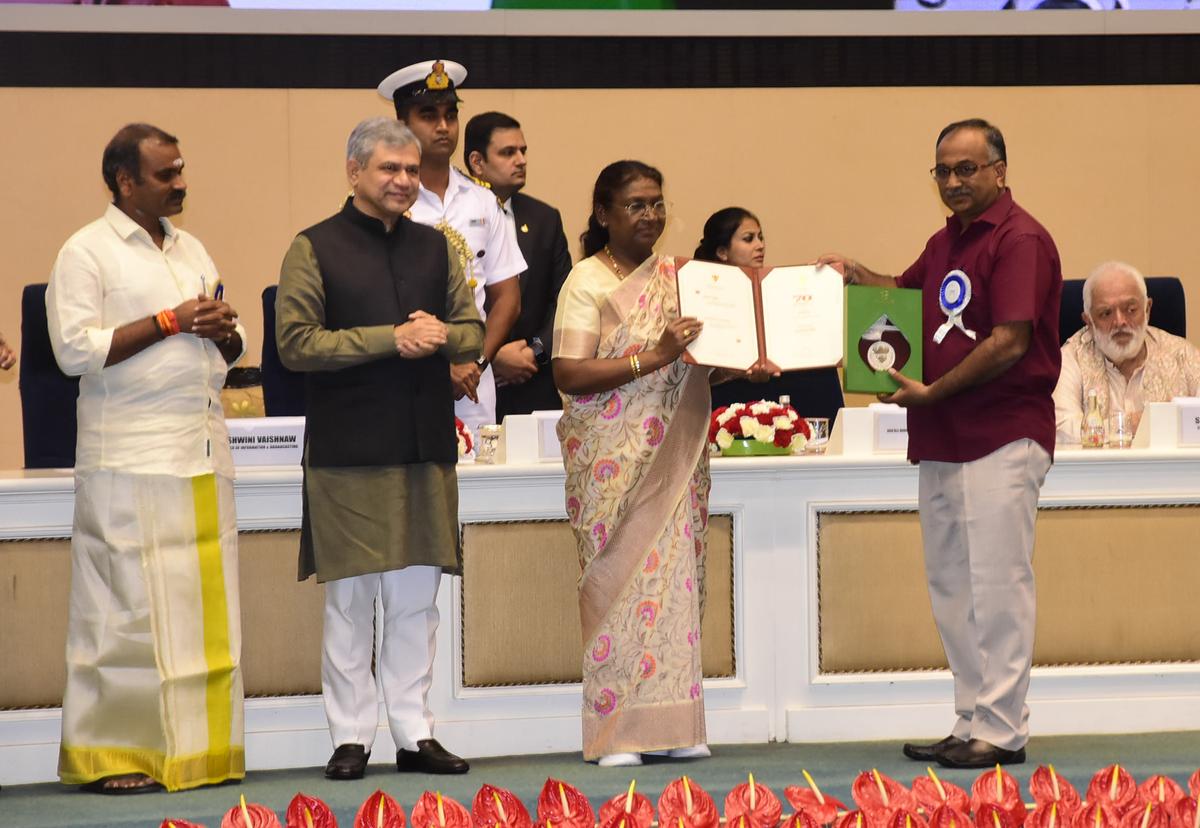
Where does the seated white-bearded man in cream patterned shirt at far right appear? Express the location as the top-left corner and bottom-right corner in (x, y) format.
(1054, 262), (1200, 445)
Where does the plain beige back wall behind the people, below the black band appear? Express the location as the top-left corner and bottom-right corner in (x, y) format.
(0, 84), (1200, 467)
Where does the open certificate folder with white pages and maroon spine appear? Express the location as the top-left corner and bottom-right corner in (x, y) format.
(676, 258), (845, 371)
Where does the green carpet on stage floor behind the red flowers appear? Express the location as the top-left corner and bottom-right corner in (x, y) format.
(0, 731), (1200, 828)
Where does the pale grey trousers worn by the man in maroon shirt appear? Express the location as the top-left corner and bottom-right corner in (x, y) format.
(919, 439), (1050, 750)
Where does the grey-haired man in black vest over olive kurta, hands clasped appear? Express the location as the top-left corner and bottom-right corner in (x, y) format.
(276, 118), (484, 779)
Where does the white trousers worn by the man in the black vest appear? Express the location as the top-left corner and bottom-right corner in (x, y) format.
(320, 566), (442, 751)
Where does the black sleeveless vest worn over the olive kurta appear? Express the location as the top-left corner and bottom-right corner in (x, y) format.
(301, 200), (458, 467)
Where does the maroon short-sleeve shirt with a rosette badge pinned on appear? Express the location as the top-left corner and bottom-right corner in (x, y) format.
(898, 190), (1062, 463)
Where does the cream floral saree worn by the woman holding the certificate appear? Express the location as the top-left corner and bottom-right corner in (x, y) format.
(558, 258), (709, 760)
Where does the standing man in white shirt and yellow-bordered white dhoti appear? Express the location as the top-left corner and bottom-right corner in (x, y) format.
(46, 124), (245, 793)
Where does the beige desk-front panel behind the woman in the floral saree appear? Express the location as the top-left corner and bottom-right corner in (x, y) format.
(462, 515), (734, 686)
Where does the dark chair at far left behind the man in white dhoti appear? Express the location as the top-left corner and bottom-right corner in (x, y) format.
(18, 282), (79, 469)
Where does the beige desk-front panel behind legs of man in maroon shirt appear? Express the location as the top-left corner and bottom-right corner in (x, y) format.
(818, 506), (1200, 672)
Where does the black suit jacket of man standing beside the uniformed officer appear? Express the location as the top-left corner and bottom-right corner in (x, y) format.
(496, 193), (571, 420)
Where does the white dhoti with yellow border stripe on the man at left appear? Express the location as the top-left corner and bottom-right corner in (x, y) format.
(59, 470), (245, 791)
